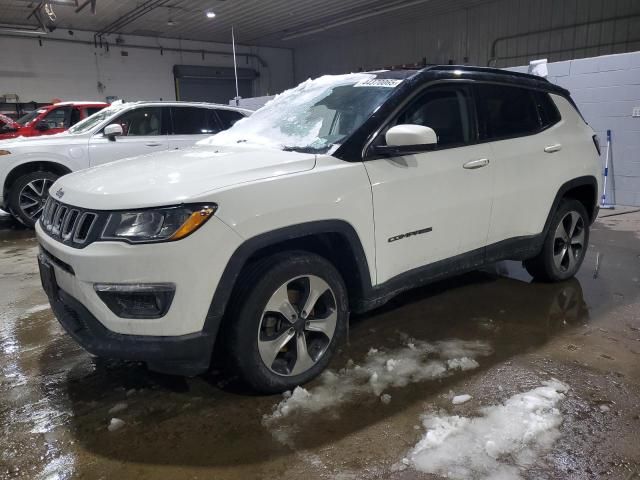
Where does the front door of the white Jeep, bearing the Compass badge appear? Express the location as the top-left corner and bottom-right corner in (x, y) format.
(365, 83), (493, 284)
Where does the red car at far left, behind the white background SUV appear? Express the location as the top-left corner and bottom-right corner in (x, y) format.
(0, 102), (109, 140)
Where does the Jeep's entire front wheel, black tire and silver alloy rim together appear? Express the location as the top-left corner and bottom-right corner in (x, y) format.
(226, 252), (348, 393)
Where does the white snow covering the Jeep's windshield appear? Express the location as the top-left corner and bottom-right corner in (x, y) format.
(198, 73), (375, 148)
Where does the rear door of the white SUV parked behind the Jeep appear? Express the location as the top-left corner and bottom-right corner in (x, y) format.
(169, 106), (222, 150)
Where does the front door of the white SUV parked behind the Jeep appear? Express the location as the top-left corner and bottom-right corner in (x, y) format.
(89, 107), (170, 166)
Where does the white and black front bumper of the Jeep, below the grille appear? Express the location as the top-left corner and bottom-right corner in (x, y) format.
(36, 217), (241, 375)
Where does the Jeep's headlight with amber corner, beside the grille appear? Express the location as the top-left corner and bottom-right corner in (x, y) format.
(100, 204), (218, 243)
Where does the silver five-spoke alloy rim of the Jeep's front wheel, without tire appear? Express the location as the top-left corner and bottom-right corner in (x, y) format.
(258, 275), (338, 376)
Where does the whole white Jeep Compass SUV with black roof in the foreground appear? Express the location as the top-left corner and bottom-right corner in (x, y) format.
(36, 66), (600, 392)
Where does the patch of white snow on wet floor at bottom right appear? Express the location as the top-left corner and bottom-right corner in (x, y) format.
(400, 380), (569, 480)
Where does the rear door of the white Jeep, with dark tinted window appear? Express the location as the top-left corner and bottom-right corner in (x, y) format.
(476, 84), (562, 245)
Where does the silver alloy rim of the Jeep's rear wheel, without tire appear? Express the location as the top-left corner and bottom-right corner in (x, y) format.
(553, 211), (585, 272)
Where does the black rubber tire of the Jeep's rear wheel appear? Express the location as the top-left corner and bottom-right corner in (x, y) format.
(524, 198), (590, 282)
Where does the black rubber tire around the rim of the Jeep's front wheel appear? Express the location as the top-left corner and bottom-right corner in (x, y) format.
(222, 251), (348, 393)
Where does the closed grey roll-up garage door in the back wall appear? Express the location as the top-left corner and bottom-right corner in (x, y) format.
(173, 65), (258, 104)
